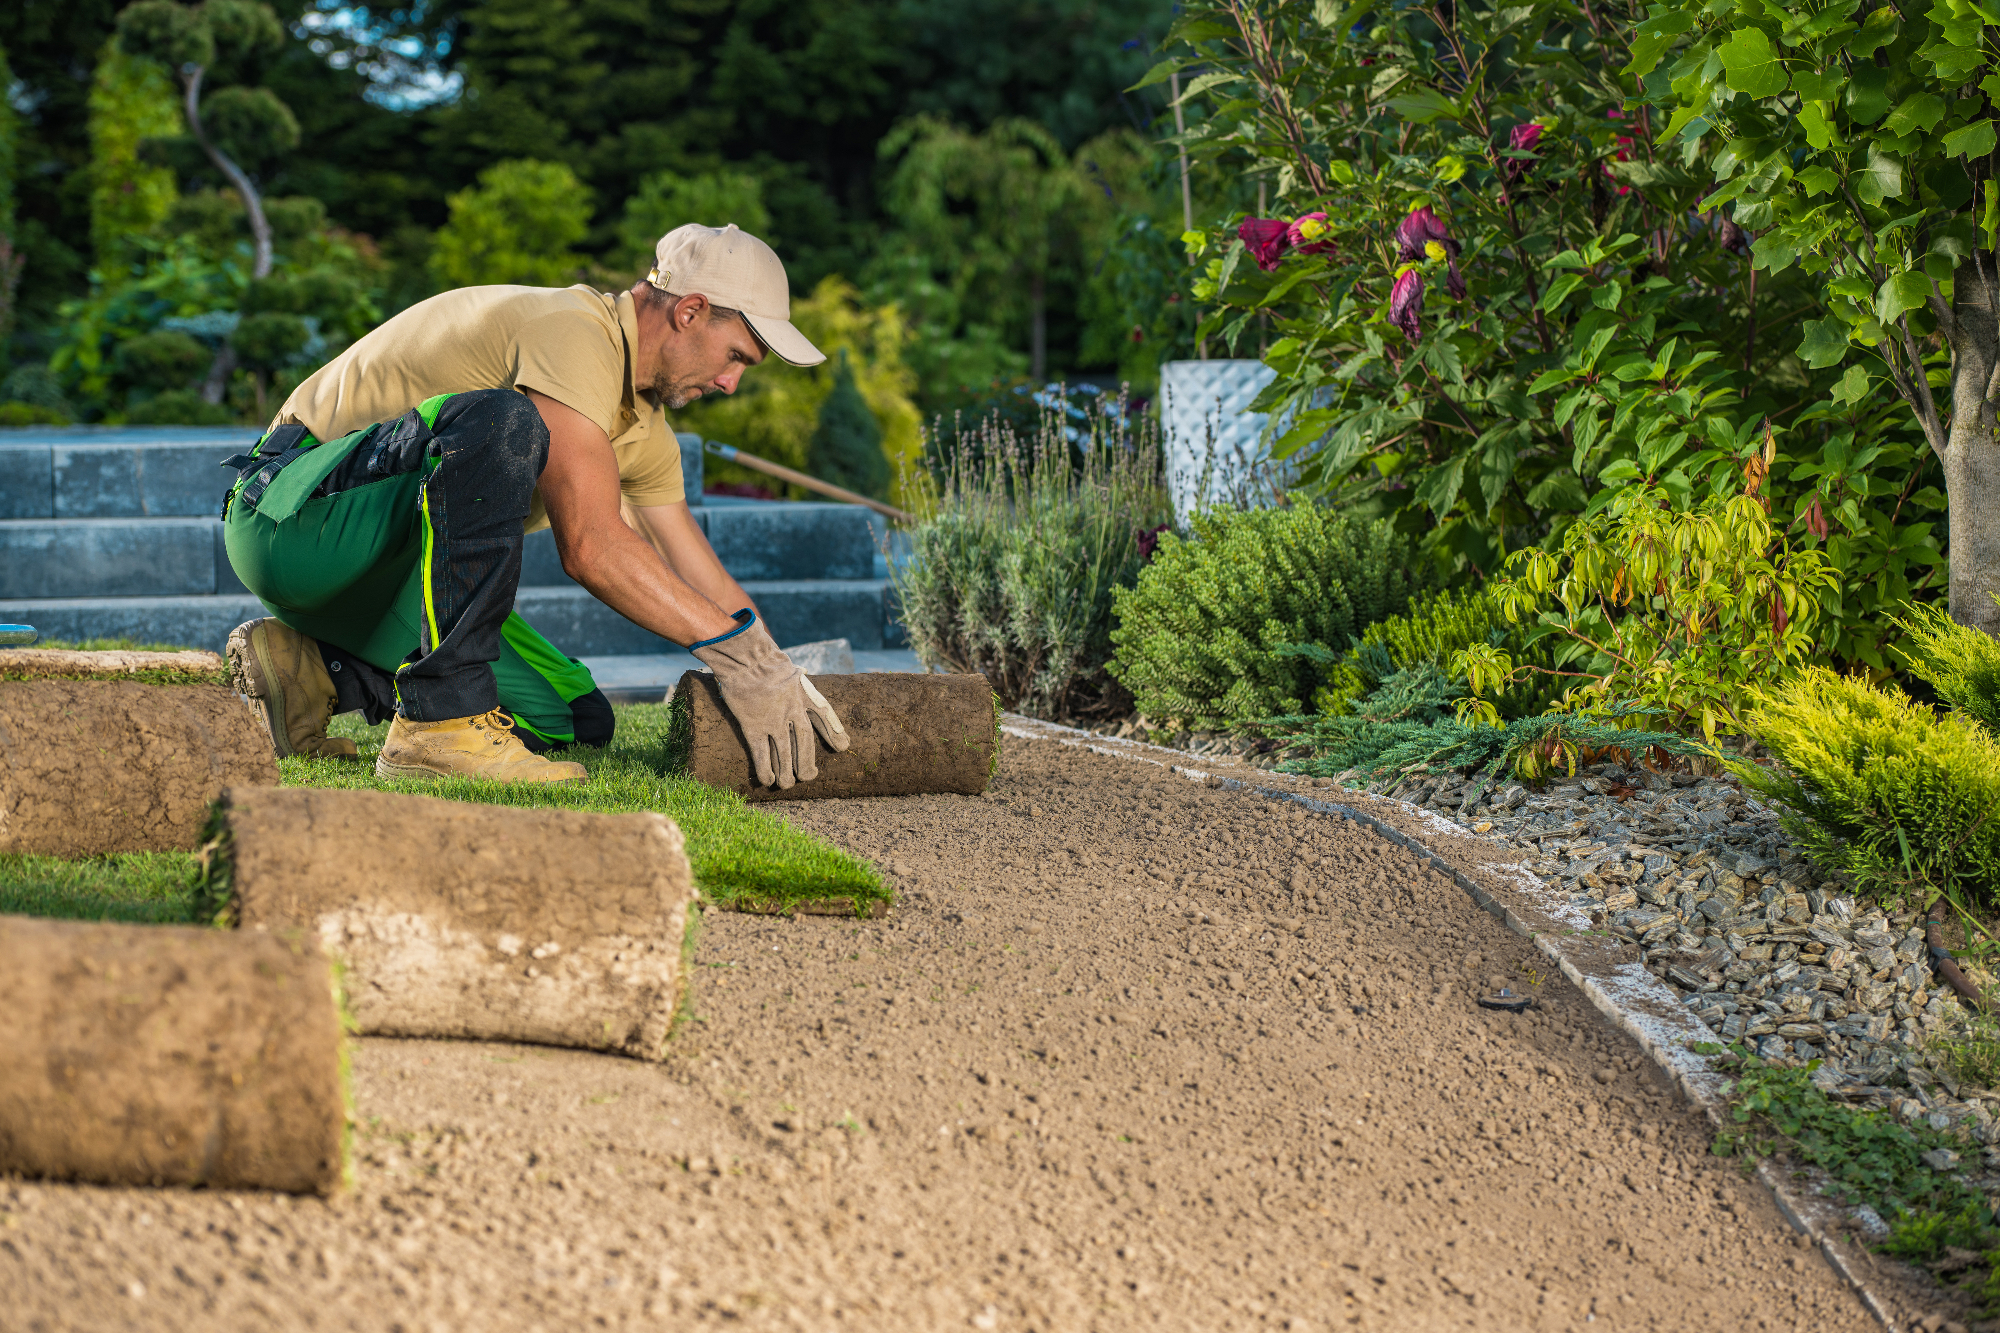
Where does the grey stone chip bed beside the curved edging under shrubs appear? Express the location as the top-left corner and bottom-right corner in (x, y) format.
(1336, 765), (2000, 1136)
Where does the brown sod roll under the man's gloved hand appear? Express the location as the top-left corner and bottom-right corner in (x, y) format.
(670, 671), (1000, 801)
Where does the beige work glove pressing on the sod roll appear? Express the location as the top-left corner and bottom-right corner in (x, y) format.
(688, 608), (848, 791)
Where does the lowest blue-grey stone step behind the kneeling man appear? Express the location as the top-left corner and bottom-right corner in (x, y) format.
(0, 578), (904, 660)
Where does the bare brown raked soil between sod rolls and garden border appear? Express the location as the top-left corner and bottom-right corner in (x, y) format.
(0, 741), (1922, 1333)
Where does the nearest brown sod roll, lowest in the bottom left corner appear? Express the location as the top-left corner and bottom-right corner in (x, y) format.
(0, 917), (346, 1195)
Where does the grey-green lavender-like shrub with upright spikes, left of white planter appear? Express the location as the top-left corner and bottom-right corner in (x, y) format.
(896, 400), (1168, 719)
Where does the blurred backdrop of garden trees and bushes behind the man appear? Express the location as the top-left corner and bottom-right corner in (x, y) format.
(0, 0), (1192, 488)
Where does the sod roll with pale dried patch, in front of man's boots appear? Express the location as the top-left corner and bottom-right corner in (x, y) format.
(202, 787), (696, 1059)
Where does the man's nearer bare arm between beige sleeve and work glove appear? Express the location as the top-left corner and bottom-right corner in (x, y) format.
(526, 388), (736, 644)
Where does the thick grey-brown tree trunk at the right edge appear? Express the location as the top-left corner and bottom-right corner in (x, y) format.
(1940, 252), (2000, 636)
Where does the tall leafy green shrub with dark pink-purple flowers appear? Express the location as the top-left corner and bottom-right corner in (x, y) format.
(1154, 0), (1942, 673)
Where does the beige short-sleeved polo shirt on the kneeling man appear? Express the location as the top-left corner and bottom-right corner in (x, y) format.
(274, 286), (688, 532)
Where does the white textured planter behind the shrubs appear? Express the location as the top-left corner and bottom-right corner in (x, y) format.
(1160, 360), (1292, 516)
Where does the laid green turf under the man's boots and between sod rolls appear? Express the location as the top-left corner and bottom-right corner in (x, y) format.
(0, 705), (892, 921)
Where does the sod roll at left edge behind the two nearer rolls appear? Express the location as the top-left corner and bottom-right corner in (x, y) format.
(0, 681), (278, 857)
